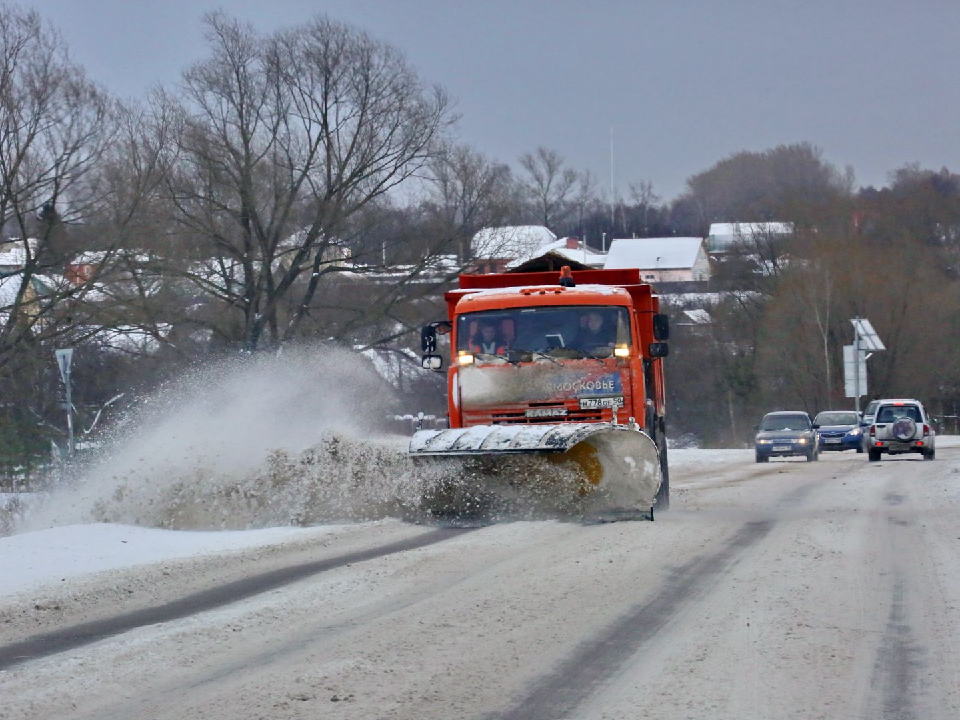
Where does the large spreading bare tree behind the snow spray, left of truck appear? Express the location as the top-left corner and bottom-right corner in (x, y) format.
(158, 13), (448, 349)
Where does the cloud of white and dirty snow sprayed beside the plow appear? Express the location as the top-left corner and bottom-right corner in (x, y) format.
(23, 349), (420, 529)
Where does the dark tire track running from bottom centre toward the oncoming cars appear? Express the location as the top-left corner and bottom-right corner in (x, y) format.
(488, 480), (824, 720)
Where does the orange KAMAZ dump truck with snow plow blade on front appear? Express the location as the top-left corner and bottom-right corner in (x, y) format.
(410, 267), (670, 519)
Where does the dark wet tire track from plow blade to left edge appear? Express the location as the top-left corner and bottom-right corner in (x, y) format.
(0, 528), (475, 672)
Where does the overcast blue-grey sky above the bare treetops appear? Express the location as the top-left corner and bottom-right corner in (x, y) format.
(21, 0), (960, 199)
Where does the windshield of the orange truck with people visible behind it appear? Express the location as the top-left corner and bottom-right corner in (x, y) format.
(457, 305), (631, 359)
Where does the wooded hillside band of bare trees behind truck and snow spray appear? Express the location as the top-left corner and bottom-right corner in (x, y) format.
(0, 4), (960, 473)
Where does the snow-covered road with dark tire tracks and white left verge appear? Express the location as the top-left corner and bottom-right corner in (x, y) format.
(0, 438), (960, 720)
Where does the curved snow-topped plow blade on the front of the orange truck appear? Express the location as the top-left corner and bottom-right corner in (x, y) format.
(409, 423), (661, 520)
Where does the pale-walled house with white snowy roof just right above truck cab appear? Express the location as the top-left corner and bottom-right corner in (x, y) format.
(603, 237), (710, 282)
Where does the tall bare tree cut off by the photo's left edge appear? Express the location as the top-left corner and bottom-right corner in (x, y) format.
(0, 6), (114, 366)
